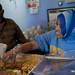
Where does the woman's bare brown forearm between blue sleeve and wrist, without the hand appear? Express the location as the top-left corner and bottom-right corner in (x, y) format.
(13, 40), (39, 53)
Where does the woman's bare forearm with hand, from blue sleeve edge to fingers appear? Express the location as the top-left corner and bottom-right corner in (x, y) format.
(4, 40), (39, 57)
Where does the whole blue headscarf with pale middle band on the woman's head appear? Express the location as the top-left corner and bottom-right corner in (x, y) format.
(57, 10), (75, 38)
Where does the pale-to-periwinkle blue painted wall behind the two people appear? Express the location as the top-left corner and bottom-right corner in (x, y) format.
(1, 0), (75, 31)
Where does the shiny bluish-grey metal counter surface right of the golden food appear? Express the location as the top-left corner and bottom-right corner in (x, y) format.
(30, 59), (75, 75)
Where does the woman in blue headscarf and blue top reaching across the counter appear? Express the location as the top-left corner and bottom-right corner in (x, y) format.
(6, 10), (75, 56)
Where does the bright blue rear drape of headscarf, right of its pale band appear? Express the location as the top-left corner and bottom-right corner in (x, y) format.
(65, 10), (75, 37)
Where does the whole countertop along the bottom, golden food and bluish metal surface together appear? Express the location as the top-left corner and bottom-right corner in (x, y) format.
(0, 51), (75, 75)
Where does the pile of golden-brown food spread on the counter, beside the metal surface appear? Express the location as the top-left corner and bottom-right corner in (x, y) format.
(0, 54), (42, 75)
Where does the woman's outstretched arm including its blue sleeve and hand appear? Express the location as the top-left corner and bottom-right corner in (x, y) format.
(6, 31), (49, 56)
